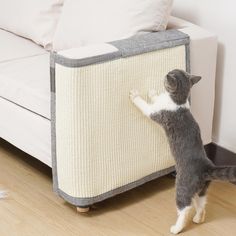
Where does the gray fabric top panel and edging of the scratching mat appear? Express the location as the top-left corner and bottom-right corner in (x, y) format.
(51, 29), (189, 67)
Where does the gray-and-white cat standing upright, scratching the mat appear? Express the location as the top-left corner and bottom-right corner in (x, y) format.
(130, 69), (236, 234)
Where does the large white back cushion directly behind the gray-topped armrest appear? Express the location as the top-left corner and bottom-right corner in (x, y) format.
(53, 0), (173, 51)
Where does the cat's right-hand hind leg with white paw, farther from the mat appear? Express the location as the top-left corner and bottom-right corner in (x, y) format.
(193, 181), (210, 224)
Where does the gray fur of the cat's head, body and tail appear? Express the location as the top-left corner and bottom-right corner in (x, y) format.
(150, 70), (236, 210)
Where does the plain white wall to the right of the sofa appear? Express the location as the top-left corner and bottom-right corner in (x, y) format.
(173, 0), (236, 153)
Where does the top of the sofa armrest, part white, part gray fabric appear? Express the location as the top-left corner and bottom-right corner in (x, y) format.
(52, 29), (189, 67)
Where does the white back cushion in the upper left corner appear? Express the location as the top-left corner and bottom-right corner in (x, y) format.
(0, 0), (64, 49)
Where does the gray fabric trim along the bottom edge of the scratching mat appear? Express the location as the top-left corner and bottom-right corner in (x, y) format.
(57, 166), (175, 207)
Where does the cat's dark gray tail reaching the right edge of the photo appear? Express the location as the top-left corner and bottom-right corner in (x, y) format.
(208, 166), (236, 182)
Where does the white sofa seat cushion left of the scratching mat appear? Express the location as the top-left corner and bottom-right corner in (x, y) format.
(0, 30), (50, 119)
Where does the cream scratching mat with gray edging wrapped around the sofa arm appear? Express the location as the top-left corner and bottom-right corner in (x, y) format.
(51, 30), (189, 206)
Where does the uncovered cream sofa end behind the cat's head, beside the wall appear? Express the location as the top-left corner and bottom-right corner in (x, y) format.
(169, 17), (217, 144)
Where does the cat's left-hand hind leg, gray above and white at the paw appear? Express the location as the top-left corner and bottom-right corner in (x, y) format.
(170, 186), (193, 234)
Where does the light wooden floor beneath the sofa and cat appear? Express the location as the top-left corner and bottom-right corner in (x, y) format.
(0, 141), (236, 236)
